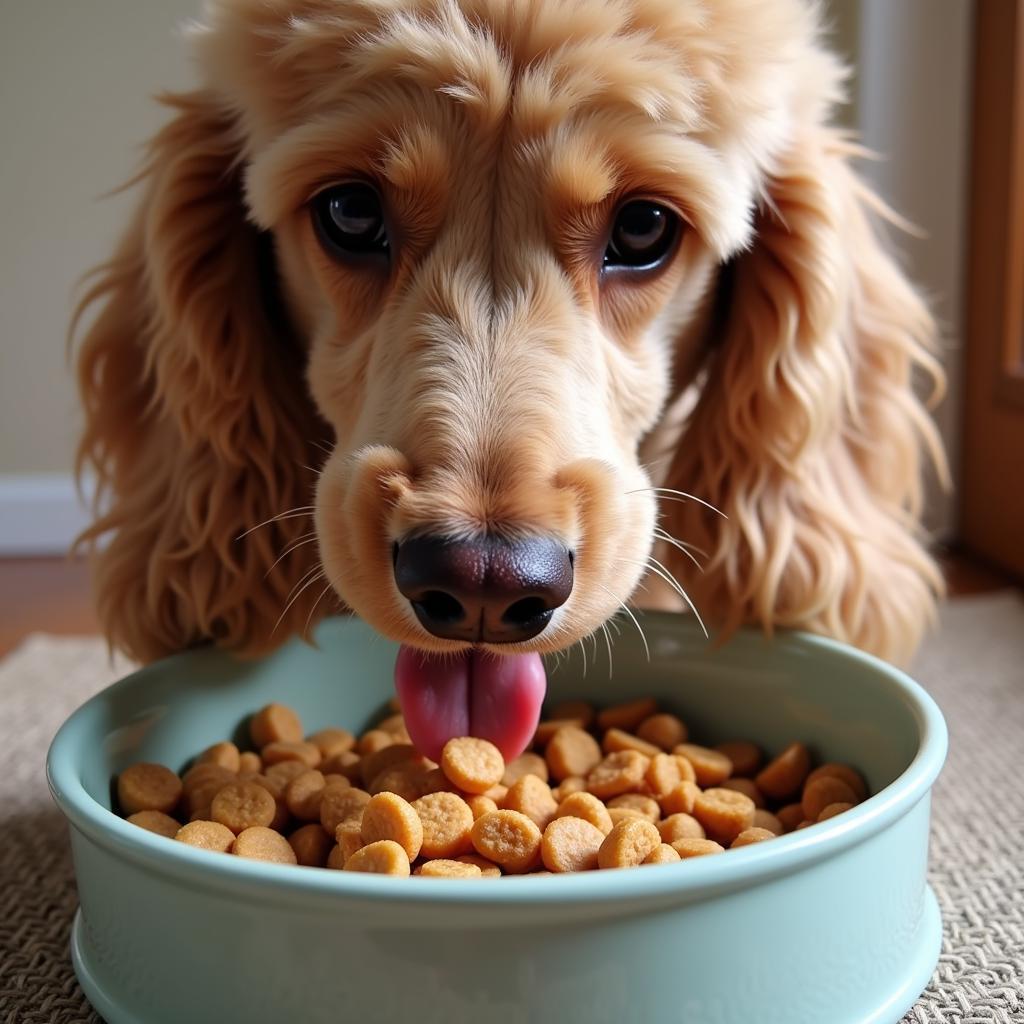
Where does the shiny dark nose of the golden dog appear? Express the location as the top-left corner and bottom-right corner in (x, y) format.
(394, 535), (572, 643)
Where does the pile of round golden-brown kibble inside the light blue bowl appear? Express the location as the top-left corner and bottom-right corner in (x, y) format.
(116, 697), (868, 880)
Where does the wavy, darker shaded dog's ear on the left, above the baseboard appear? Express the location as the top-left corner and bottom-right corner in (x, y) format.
(78, 91), (324, 659)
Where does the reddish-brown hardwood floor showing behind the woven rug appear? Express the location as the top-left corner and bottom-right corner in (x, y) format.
(0, 550), (1014, 655)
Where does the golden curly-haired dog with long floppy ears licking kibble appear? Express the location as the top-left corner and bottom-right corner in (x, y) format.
(78, 0), (944, 752)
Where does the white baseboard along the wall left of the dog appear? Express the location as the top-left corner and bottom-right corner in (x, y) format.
(0, 473), (93, 556)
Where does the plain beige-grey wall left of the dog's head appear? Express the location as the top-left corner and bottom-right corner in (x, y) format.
(0, 0), (199, 474)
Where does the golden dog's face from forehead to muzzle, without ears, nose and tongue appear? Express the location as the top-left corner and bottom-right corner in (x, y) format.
(204, 0), (819, 650)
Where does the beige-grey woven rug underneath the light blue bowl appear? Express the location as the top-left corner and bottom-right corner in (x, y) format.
(0, 592), (1024, 1024)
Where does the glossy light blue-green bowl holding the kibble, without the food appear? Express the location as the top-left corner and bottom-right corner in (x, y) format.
(47, 614), (946, 1024)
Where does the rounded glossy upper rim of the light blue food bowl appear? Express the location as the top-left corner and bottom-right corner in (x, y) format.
(46, 611), (948, 910)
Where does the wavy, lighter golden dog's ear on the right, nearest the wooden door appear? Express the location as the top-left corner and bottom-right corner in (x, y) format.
(664, 127), (945, 660)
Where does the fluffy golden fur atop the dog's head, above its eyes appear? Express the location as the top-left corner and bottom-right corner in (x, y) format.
(194, 0), (842, 257)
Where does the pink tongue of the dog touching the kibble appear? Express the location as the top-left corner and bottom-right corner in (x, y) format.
(394, 645), (547, 761)
